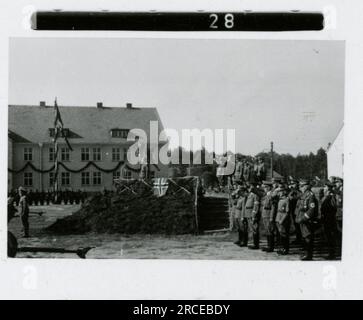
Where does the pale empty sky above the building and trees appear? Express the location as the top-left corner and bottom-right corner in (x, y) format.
(9, 38), (344, 155)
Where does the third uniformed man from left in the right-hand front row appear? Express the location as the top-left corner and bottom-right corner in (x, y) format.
(261, 181), (275, 252)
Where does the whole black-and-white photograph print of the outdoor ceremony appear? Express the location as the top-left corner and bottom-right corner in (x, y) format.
(7, 37), (345, 261)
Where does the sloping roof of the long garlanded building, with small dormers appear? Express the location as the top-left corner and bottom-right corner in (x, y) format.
(8, 105), (164, 144)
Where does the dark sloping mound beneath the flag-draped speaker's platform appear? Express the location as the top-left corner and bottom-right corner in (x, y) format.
(46, 179), (197, 234)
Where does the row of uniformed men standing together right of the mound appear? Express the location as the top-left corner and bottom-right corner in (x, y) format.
(230, 177), (343, 260)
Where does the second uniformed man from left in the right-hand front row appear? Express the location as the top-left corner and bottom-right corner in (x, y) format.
(244, 184), (260, 250)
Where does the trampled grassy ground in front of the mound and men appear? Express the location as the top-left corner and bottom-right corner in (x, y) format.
(9, 205), (338, 260)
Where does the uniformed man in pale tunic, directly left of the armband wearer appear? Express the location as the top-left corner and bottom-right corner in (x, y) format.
(276, 186), (291, 255)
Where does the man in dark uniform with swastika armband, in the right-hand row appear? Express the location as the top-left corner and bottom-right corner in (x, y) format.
(296, 180), (318, 261)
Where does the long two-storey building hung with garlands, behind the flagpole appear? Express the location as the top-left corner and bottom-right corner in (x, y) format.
(8, 102), (167, 191)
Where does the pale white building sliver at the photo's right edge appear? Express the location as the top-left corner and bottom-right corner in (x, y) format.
(327, 127), (344, 178)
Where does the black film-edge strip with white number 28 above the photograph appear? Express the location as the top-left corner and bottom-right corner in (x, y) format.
(32, 10), (324, 32)
